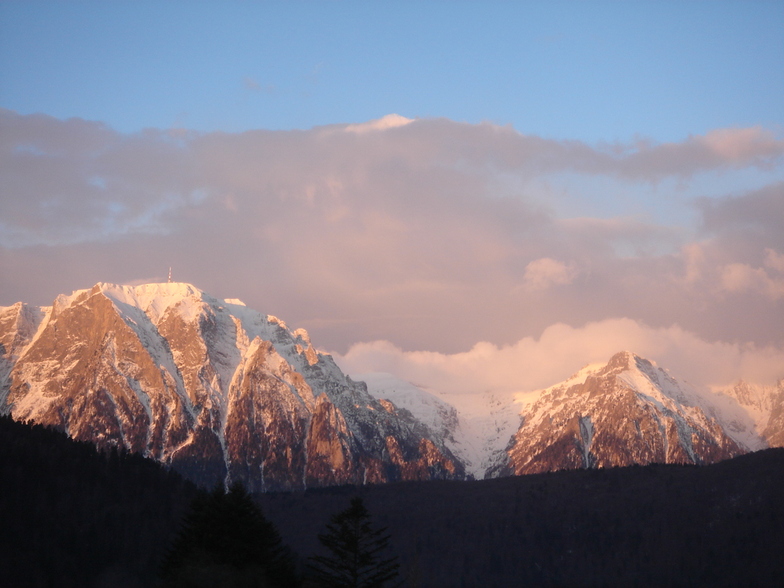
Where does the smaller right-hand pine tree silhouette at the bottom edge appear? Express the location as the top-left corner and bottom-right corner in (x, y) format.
(308, 497), (399, 588)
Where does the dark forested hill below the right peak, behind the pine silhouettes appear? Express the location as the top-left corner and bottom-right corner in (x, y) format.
(259, 449), (784, 588)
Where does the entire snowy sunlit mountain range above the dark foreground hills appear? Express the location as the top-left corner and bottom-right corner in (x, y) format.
(0, 283), (784, 491)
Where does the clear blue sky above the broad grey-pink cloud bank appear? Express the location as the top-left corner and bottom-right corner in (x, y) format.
(0, 1), (784, 143)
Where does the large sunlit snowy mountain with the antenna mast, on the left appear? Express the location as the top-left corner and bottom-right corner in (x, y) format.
(0, 284), (464, 491)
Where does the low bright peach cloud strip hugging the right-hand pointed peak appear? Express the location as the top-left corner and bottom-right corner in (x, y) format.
(335, 319), (784, 395)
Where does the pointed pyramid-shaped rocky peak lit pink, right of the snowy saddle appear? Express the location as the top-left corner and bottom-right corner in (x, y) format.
(488, 352), (749, 477)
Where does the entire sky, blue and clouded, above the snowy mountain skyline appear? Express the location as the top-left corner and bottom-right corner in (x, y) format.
(0, 1), (784, 400)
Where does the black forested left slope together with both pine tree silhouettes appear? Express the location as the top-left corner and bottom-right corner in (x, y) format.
(0, 416), (398, 588)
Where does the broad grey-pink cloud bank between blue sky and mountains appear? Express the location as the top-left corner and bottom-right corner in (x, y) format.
(0, 110), (784, 388)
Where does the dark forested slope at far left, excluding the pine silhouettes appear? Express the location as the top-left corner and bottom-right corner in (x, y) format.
(0, 417), (197, 588)
